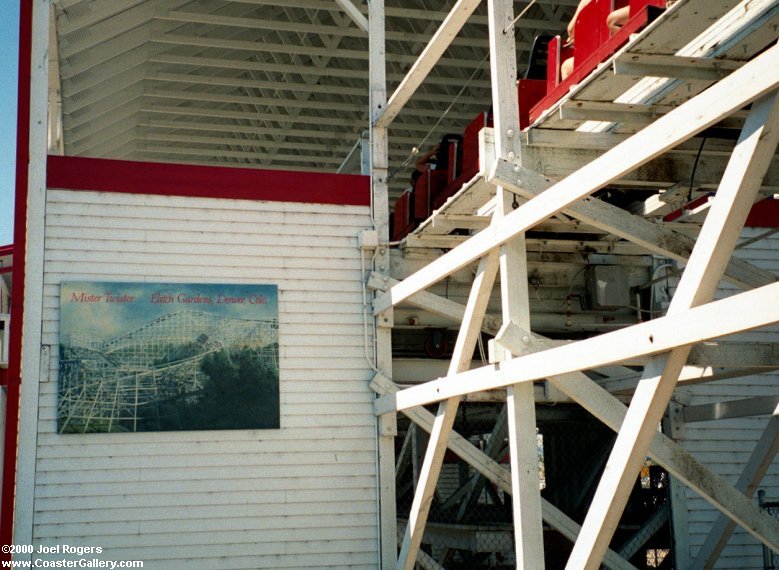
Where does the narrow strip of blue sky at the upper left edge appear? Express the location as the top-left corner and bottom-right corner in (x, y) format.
(0, 0), (19, 245)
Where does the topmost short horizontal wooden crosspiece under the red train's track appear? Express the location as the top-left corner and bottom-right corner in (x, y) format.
(613, 52), (744, 81)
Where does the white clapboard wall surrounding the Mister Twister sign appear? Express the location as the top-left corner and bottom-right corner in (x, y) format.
(33, 190), (378, 569)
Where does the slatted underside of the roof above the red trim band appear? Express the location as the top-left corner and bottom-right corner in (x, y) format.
(54, 0), (576, 194)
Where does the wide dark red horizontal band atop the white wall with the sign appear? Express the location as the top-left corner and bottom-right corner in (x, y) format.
(46, 156), (370, 206)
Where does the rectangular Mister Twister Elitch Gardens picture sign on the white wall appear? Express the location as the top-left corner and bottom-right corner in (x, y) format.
(57, 282), (279, 433)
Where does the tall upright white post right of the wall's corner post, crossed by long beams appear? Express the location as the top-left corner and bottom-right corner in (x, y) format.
(487, 0), (544, 569)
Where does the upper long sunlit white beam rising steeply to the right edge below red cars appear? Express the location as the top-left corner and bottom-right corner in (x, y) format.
(374, 46), (779, 312)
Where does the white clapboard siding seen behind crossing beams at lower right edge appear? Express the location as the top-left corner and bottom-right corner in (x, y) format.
(681, 228), (779, 569)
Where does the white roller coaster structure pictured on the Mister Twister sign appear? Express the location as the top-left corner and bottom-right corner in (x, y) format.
(58, 311), (278, 432)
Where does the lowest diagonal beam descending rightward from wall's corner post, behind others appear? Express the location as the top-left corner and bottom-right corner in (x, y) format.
(371, 374), (635, 570)
